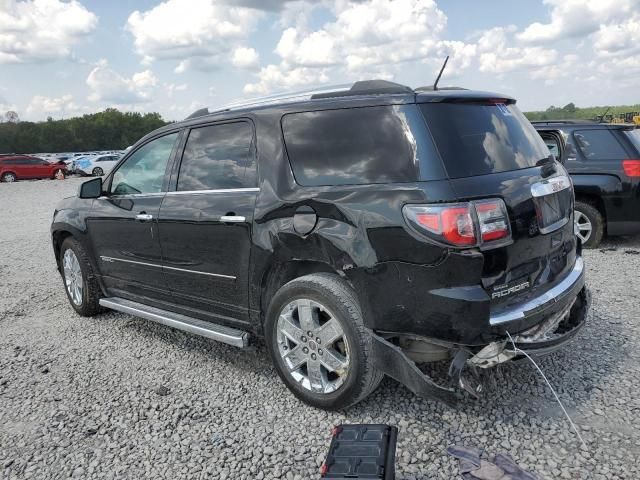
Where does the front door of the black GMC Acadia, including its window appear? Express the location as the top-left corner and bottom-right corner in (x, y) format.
(87, 132), (179, 298)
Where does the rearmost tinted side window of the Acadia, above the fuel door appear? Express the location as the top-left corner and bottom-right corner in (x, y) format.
(282, 105), (432, 186)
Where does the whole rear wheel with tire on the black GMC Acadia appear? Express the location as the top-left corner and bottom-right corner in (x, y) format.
(265, 273), (384, 410)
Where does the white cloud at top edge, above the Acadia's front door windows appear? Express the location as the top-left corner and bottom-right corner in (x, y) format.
(127, 0), (262, 73)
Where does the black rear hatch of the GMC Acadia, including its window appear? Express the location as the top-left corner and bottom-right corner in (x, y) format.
(420, 98), (576, 310)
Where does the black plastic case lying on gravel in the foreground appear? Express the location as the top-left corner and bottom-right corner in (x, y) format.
(320, 425), (398, 480)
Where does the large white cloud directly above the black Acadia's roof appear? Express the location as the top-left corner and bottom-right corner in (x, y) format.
(245, 0), (450, 92)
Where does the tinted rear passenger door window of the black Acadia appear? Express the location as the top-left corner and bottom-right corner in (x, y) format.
(178, 122), (256, 191)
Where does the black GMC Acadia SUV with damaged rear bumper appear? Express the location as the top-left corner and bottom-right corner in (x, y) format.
(51, 81), (589, 409)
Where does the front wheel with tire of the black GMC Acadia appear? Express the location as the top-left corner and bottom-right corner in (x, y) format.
(60, 237), (102, 317)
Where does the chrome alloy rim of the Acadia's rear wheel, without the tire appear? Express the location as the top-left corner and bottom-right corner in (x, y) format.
(277, 298), (349, 394)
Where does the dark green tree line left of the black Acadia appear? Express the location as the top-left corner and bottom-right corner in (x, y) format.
(0, 108), (168, 153)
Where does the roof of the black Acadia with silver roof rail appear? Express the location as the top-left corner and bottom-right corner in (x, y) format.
(185, 80), (515, 120)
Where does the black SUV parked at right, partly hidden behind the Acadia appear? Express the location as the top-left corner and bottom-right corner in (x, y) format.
(533, 120), (640, 247)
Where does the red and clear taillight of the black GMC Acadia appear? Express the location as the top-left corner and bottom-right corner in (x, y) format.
(402, 198), (511, 248)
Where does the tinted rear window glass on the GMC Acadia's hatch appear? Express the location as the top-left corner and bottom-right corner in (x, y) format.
(420, 103), (549, 178)
